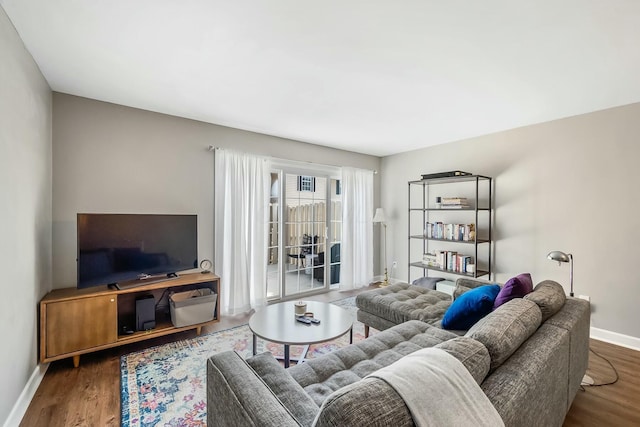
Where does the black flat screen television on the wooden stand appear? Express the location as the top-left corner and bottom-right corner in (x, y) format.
(77, 213), (198, 289)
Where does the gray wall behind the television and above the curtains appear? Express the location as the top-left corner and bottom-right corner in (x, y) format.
(53, 93), (380, 288)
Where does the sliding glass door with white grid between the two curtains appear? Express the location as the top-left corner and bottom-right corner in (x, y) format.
(267, 170), (342, 300)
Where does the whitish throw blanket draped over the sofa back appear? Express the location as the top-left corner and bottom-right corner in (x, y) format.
(369, 348), (504, 427)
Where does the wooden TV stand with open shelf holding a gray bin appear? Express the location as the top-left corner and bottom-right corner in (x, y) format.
(39, 273), (220, 367)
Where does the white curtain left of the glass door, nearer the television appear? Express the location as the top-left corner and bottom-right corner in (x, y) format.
(215, 149), (271, 315)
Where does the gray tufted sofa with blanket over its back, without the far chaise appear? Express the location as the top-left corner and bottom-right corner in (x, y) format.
(207, 281), (590, 427)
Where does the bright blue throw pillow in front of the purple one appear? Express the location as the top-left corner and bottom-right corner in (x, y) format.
(442, 285), (500, 330)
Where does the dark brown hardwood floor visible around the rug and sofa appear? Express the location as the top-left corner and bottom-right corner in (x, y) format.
(20, 291), (640, 427)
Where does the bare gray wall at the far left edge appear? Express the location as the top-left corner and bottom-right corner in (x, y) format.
(0, 7), (51, 424)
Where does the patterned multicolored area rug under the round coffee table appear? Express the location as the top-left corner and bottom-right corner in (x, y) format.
(120, 297), (364, 427)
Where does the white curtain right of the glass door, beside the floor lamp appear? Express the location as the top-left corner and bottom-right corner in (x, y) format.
(340, 168), (373, 290)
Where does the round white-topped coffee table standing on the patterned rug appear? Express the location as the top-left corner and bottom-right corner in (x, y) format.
(249, 301), (354, 368)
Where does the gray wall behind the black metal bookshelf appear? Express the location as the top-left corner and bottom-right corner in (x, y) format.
(381, 104), (640, 337)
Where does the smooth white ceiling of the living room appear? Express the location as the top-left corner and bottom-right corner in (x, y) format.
(0, 0), (640, 156)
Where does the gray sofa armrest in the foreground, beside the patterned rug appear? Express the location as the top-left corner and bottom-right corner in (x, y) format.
(207, 351), (300, 427)
